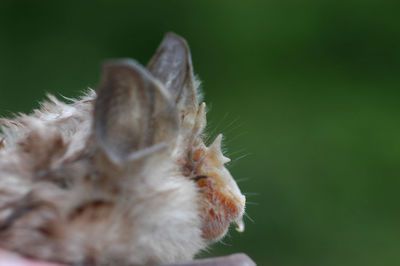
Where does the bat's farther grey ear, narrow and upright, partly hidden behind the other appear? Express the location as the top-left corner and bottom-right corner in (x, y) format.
(147, 33), (198, 114)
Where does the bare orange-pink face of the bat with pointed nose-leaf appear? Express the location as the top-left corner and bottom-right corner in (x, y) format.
(183, 129), (246, 241)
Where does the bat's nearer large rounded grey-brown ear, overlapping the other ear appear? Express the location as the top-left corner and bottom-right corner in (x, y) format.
(94, 59), (179, 163)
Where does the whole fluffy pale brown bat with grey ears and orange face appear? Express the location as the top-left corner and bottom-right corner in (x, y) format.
(0, 33), (245, 265)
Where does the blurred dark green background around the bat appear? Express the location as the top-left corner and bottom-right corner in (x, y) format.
(0, 1), (400, 265)
